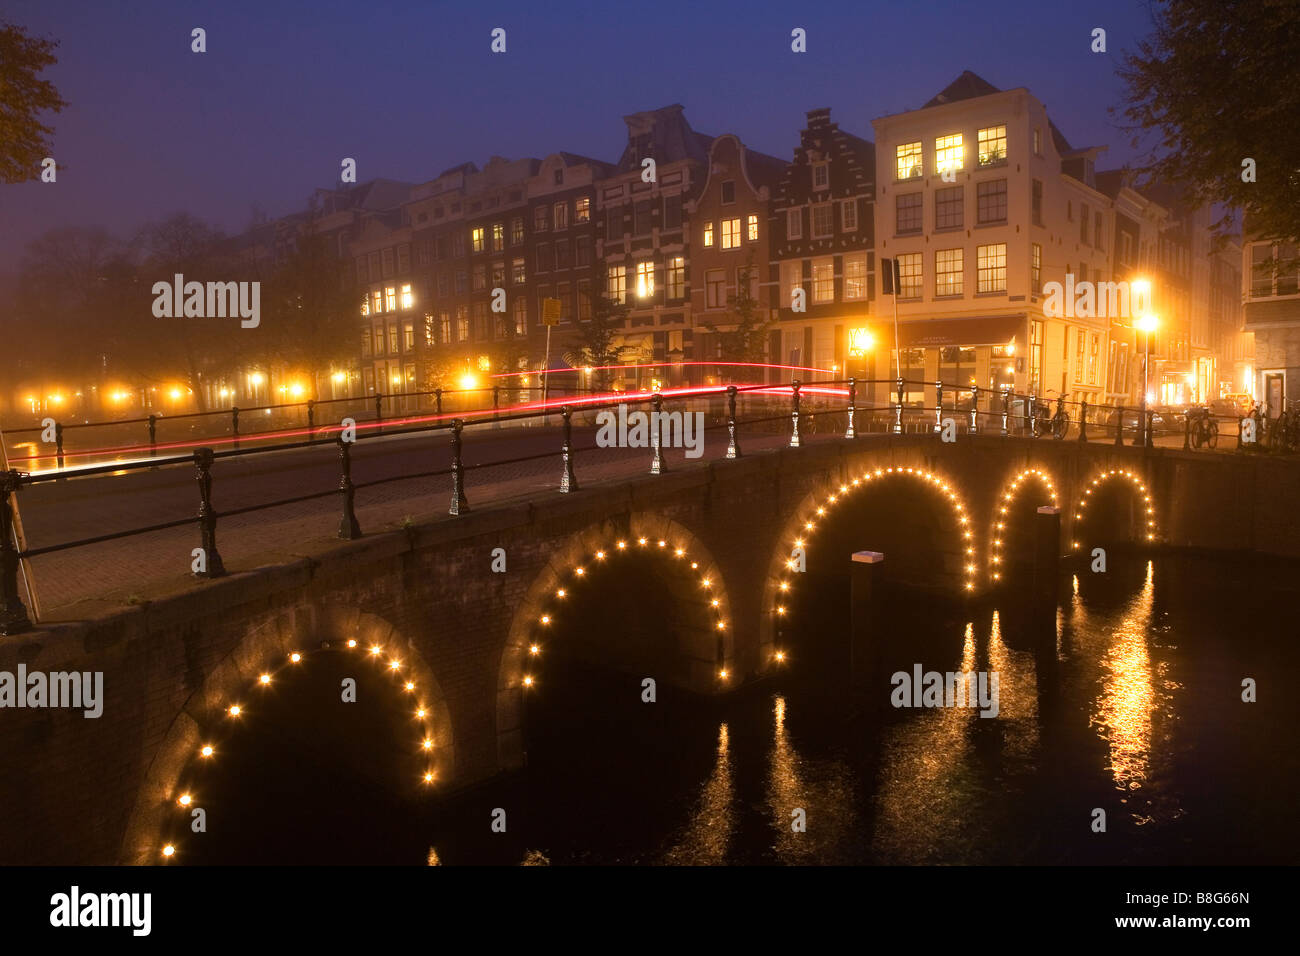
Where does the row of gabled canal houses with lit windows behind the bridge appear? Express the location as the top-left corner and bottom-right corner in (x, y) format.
(245, 72), (1251, 408)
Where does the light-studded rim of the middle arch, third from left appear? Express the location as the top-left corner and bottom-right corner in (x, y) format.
(761, 466), (979, 666)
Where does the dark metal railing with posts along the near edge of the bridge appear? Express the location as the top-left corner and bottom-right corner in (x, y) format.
(0, 378), (1279, 635)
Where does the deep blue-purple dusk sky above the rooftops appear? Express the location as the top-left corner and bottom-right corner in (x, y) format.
(0, 0), (1151, 269)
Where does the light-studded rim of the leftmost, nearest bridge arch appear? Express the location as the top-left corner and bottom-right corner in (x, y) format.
(120, 605), (455, 865)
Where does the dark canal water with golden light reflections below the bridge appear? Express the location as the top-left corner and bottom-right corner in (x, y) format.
(176, 555), (1300, 865)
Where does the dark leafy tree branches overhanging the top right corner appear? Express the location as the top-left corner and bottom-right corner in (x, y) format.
(1112, 0), (1300, 238)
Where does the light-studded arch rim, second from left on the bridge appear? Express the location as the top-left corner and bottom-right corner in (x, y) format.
(497, 512), (736, 766)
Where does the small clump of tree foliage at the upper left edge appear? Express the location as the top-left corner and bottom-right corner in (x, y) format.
(0, 23), (68, 182)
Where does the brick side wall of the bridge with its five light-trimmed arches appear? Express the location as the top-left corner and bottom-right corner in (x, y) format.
(0, 434), (1300, 864)
